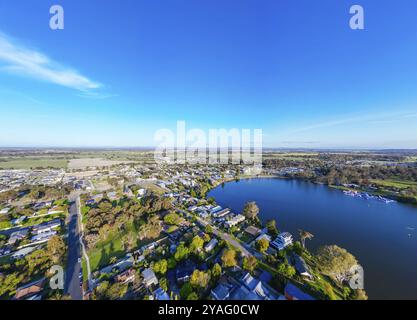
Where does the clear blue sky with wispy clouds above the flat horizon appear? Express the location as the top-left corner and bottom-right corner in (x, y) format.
(0, 0), (417, 148)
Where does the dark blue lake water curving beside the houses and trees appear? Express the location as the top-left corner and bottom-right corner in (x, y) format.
(209, 179), (417, 299)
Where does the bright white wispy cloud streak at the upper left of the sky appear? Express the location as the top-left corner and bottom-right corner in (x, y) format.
(0, 32), (103, 94)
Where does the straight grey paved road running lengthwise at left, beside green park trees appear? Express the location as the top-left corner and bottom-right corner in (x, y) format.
(65, 199), (83, 300)
